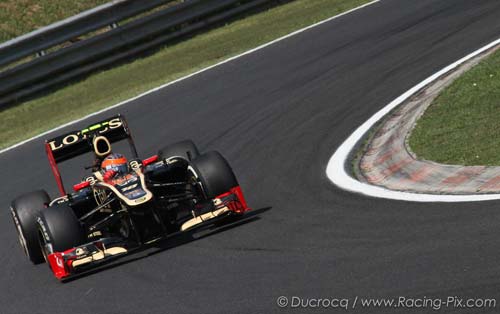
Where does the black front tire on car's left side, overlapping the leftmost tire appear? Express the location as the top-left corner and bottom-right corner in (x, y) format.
(37, 204), (87, 255)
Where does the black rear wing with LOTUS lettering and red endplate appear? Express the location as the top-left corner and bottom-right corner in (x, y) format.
(45, 115), (137, 195)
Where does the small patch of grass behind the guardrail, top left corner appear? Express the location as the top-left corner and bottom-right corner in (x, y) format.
(0, 0), (109, 43)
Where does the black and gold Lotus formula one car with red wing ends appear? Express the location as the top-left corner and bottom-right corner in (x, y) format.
(7, 115), (250, 280)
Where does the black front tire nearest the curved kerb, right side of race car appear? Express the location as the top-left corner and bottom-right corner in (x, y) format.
(191, 151), (239, 199)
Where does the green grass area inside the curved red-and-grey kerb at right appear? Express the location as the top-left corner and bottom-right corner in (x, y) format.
(410, 51), (500, 165)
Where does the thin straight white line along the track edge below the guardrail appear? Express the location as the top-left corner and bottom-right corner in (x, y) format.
(0, 0), (380, 154)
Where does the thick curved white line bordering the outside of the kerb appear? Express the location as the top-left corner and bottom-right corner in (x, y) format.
(326, 39), (500, 202)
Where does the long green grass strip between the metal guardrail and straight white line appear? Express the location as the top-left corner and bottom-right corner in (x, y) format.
(0, 0), (369, 147)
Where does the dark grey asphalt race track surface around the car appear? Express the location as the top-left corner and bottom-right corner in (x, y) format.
(0, 0), (500, 314)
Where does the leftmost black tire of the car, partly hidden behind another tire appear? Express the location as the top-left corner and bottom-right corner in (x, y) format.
(11, 190), (50, 264)
